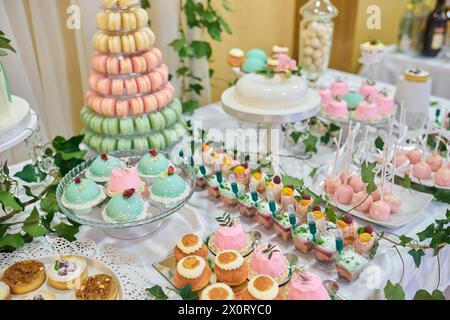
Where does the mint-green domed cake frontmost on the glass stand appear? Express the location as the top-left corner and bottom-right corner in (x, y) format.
(102, 189), (148, 223)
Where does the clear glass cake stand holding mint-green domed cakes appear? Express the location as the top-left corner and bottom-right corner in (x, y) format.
(56, 151), (195, 240)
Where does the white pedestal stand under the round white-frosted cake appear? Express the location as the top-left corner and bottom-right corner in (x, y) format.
(222, 87), (321, 154)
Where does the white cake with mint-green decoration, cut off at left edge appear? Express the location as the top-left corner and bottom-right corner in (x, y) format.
(0, 63), (31, 144)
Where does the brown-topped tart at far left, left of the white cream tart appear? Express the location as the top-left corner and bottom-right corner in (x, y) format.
(1, 260), (46, 295)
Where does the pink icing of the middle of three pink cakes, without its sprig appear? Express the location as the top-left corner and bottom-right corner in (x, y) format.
(250, 244), (288, 278)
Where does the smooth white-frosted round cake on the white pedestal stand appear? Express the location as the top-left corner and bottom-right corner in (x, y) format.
(235, 74), (308, 109)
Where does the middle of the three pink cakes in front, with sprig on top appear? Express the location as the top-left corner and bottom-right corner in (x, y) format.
(250, 243), (289, 282)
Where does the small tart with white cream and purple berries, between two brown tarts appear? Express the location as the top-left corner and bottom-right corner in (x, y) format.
(47, 256), (89, 290)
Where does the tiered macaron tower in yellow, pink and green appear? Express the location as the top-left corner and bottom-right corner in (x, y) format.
(81, 0), (186, 153)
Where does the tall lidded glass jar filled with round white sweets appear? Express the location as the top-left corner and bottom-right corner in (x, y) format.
(299, 0), (339, 84)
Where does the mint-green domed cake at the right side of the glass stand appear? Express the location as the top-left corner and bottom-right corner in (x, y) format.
(150, 166), (190, 204)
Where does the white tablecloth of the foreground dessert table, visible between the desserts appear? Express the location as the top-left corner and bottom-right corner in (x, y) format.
(4, 71), (450, 300)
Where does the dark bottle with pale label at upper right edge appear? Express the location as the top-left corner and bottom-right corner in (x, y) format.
(422, 0), (447, 57)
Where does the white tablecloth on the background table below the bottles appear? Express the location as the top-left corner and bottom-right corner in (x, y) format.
(360, 46), (450, 99)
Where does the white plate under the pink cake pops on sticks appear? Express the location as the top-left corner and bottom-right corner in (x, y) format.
(311, 175), (433, 229)
